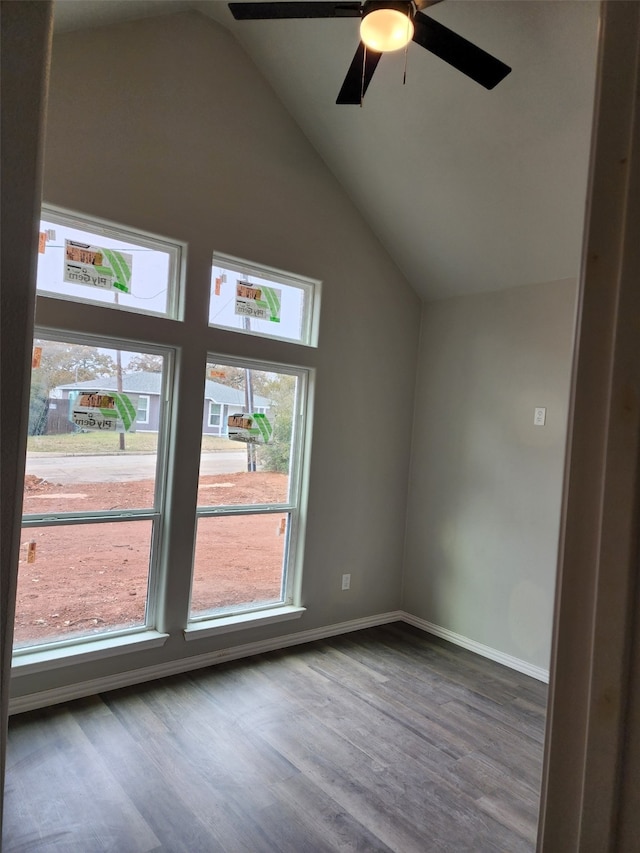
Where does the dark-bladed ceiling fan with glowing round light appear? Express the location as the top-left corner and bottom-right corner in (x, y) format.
(229, 0), (511, 104)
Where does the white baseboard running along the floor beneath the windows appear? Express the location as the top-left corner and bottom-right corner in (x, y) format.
(9, 610), (404, 714)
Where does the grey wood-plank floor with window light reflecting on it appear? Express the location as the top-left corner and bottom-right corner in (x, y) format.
(3, 623), (546, 853)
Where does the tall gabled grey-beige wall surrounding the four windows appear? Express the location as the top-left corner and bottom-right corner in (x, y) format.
(14, 13), (420, 696)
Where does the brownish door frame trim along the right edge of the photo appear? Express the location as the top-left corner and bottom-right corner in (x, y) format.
(537, 8), (640, 853)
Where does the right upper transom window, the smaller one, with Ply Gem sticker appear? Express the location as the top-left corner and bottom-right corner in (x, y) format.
(209, 255), (319, 344)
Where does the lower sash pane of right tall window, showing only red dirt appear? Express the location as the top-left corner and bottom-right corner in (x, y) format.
(191, 513), (288, 618)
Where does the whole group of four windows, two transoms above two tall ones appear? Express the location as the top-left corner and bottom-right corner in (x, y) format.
(14, 209), (319, 667)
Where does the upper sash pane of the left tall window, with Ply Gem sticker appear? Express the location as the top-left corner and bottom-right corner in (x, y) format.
(24, 338), (164, 515)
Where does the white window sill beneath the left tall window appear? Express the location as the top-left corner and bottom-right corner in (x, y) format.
(11, 630), (169, 675)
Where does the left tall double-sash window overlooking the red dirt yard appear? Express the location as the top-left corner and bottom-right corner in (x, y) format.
(15, 335), (170, 648)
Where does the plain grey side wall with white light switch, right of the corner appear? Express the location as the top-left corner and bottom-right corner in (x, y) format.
(403, 280), (576, 669)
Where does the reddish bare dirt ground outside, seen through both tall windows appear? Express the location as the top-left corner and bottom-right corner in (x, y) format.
(15, 471), (287, 647)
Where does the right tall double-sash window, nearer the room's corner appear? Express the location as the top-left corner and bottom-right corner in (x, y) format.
(189, 357), (306, 624)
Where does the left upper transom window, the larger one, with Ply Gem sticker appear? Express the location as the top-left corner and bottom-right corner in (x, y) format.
(37, 212), (180, 316)
